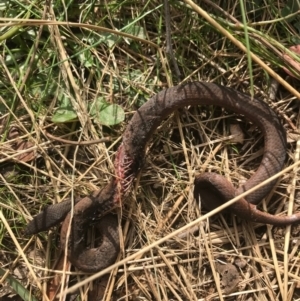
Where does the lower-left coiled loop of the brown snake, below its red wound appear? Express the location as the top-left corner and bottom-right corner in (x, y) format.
(60, 180), (120, 273)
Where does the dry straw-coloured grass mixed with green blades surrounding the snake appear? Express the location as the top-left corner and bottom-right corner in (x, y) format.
(0, 1), (300, 301)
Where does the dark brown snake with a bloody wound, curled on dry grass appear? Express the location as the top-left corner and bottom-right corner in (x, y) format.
(25, 82), (300, 273)
